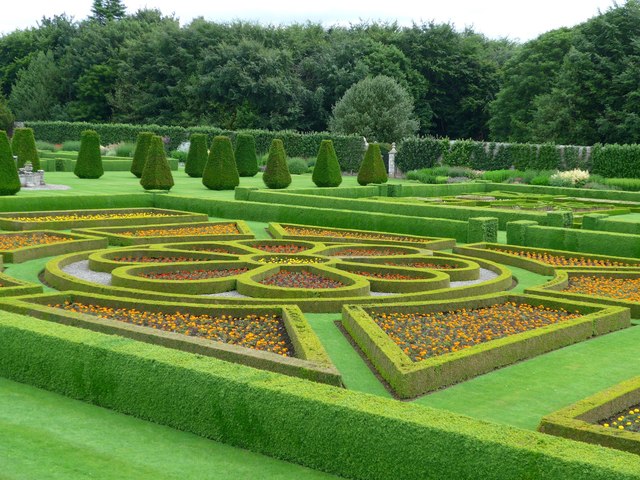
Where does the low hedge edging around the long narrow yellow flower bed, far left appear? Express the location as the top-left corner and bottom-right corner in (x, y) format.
(0, 208), (209, 231)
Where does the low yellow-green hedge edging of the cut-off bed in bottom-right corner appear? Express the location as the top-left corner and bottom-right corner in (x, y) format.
(538, 377), (640, 455)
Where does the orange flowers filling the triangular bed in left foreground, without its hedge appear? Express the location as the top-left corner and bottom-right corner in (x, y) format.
(49, 302), (294, 357)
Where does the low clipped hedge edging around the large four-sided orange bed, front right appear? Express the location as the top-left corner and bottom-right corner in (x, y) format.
(342, 294), (631, 398)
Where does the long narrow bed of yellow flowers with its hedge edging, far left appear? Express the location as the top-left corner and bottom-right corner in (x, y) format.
(0, 208), (207, 230)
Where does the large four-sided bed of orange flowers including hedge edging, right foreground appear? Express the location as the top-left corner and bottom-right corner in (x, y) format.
(342, 294), (631, 398)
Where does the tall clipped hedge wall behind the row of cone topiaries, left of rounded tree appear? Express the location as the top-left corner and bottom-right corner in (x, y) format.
(26, 121), (364, 172)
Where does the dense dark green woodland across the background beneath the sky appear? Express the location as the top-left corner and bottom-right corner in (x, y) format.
(0, 0), (640, 145)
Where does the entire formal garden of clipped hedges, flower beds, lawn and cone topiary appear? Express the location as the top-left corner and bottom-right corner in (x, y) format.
(0, 122), (640, 479)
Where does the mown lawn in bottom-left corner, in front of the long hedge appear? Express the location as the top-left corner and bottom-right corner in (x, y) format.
(0, 378), (337, 480)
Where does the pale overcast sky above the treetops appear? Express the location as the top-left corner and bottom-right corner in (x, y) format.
(0, 0), (624, 41)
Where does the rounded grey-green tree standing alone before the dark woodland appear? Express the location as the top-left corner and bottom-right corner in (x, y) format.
(329, 75), (419, 143)
